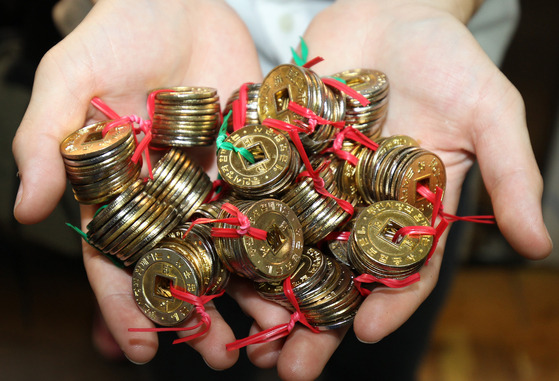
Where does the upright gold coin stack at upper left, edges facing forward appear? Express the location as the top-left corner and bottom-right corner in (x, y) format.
(151, 87), (221, 147)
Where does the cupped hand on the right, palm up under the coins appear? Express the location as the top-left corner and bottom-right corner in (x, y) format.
(241, 0), (551, 379)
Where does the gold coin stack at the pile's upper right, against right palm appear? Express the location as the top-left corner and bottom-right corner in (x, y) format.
(333, 69), (389, 139)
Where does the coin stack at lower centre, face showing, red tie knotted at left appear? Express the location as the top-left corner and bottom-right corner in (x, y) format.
(214, 199), (303, 282)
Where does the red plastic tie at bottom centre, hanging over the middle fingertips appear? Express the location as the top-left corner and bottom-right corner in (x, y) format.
(225, 277), (320, 351)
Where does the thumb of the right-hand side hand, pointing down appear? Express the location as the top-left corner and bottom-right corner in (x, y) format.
(475, 73), (552, 259)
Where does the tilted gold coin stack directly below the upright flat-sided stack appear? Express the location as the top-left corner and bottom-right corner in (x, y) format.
(144, 148), (212, 221)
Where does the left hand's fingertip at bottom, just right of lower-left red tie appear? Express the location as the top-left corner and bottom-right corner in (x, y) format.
(179, 301), (239, 370)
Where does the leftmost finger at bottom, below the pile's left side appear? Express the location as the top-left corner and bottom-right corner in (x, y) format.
(81, 206), (158, 364)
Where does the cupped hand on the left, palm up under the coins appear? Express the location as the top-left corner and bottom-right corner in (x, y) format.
(13, 0), (261, 369)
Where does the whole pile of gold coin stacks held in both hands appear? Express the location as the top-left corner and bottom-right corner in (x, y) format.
(61, 64), (446, 336)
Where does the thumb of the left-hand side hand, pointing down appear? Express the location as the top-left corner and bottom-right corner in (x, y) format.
(12, 47), (89, 224)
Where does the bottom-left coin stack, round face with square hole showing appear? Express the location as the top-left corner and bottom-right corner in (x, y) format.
(132, 223), (229, 326)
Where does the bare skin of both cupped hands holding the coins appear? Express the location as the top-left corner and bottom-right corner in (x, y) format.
(13, 0), (551, 379)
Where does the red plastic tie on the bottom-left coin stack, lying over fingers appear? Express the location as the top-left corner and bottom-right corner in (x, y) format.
(128, 284), (225, 344)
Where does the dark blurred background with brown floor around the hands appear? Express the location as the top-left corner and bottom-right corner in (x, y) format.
(0, 0), (559, 381)
